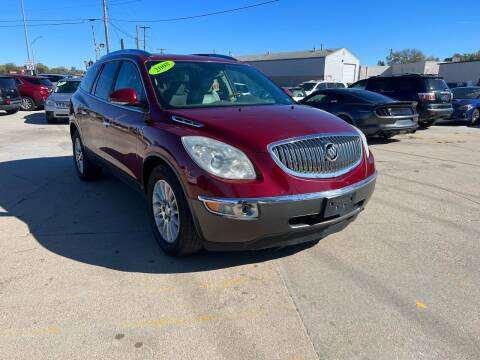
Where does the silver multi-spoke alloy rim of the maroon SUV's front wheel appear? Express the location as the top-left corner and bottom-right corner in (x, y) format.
(152, 180), (180, 244)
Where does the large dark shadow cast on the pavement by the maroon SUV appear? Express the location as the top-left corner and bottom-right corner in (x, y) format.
(0, 155), (312, 273)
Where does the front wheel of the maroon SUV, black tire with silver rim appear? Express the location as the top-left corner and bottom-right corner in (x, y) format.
(147, 166), (202, 256)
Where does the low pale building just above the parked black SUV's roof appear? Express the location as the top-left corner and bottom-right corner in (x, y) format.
(359, 61), (440, 79)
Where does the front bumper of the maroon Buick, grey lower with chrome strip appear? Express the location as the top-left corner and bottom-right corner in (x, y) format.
(190, 173), (377, 250)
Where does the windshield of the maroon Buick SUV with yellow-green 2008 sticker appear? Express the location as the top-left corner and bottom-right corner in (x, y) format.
(146, 61), (292, 108)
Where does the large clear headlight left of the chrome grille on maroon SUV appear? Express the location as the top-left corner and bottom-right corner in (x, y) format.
(182, 136), (257, 180)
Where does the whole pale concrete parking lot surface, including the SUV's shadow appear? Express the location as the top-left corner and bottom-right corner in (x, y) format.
(0, 111), (480, 360)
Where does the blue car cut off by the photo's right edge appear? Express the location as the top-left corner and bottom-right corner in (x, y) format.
(452, 86), (480, 125)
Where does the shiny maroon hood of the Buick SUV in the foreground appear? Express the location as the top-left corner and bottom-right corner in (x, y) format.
(169, 105), (355, 152)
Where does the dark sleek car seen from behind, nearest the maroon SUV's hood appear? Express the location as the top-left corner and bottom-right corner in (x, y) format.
(300, 89), (418, 138)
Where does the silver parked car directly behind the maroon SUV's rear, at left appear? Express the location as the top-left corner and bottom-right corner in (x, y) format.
(45, 78), (81, 124)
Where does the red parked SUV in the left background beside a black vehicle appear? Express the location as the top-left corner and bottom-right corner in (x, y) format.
(11, 74), (53, 111)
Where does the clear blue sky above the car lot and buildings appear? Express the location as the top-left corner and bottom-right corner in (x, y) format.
(0, 0), (480, 68)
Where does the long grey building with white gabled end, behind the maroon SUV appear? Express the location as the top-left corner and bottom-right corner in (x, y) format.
(237, 48), (360, 86)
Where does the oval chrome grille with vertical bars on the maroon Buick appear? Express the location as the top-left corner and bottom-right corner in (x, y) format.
(268, 134), (362, 178)
